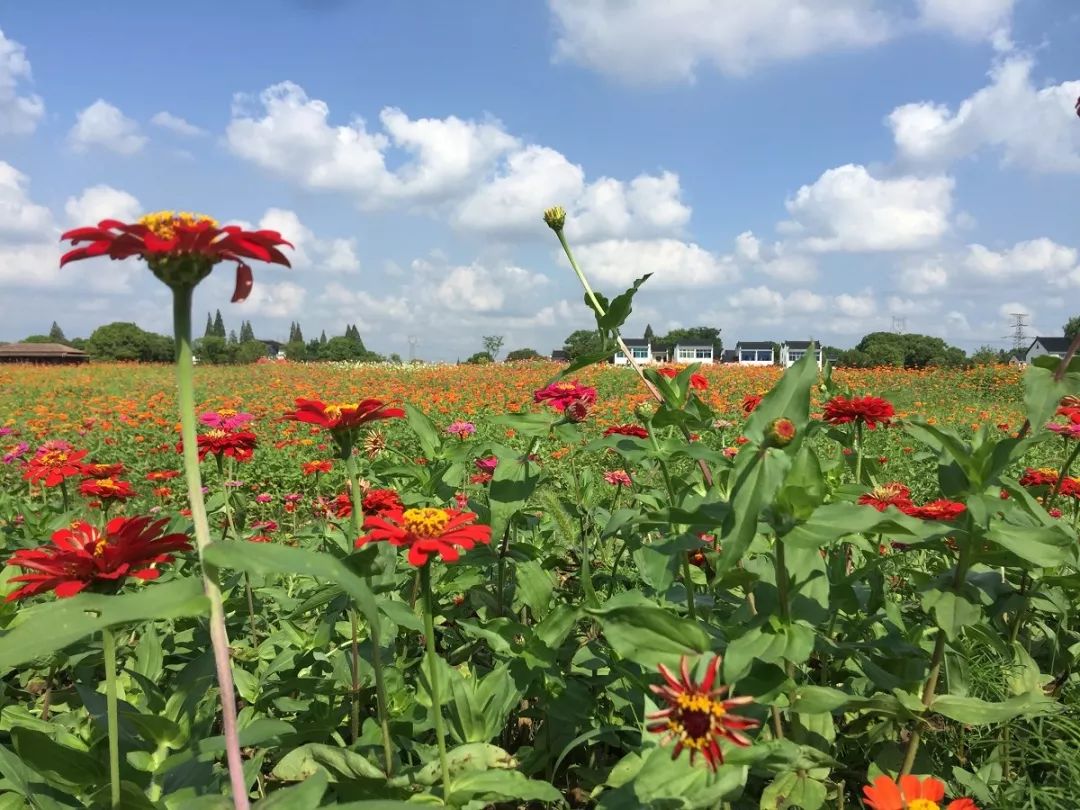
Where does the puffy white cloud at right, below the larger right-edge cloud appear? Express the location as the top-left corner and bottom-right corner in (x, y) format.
(780, 163), (954, 252)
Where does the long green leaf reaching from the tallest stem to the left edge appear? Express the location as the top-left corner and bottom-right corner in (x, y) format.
(0, 577), (208, 667)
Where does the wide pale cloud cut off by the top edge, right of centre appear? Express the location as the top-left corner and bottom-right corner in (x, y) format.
(549, 0), (893, 84)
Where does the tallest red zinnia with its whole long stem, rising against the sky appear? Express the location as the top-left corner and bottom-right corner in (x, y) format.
(60, 211), (292, 810)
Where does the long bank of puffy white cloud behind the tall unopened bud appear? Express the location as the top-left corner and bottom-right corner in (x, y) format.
(227, 82), (690, 240)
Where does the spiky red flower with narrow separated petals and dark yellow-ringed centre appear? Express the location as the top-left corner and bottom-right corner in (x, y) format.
(647, 656), (761, 771)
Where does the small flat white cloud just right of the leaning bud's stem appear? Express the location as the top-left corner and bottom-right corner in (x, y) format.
(577, 239), (739, 292)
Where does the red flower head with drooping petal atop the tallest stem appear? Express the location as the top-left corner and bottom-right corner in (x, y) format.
(60, 211), (293, 302)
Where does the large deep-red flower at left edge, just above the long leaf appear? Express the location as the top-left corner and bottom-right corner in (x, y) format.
(8, 517), (191, 602)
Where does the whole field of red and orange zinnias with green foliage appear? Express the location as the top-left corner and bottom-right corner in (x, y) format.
(0, 363), (1080, 810)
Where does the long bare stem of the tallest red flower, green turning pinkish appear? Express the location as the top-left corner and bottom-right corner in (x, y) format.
(173, 287), (251, 810)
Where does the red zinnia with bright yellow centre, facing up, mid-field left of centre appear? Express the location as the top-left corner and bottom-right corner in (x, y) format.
(356, 508), (491, 567)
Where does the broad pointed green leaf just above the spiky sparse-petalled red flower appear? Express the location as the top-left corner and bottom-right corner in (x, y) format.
(586, 602), (710, 669)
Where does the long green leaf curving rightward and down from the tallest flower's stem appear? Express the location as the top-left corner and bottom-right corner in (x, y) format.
(205, 542), (379, 635)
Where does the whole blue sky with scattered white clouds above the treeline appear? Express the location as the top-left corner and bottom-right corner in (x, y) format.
(0, 0), (1080, 360)
